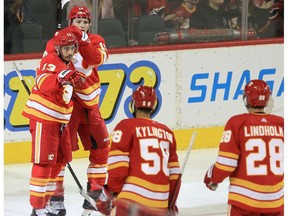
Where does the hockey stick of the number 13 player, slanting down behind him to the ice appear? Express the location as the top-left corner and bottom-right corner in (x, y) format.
(13, 62), (97, 210)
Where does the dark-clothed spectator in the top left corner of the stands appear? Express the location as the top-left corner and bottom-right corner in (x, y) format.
(4, 0), (33, 54)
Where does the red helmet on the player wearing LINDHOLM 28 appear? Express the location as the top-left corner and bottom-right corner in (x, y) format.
(243, 80), (271, 107)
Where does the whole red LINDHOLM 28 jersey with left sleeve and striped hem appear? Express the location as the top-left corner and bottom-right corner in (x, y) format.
(220, 113), (284, 212)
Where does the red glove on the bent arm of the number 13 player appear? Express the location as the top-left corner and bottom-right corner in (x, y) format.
(58, 70), (86, 87)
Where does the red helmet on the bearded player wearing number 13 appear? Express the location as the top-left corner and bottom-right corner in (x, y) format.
(54, 29), (78, 47)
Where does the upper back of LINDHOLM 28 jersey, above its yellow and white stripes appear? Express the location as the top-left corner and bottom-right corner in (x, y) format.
(231, 114), (284, 185)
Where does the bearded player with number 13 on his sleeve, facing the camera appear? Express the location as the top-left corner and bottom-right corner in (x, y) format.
(23, 30), (85, 216)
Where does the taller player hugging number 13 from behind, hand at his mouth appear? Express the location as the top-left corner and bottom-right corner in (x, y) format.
(46, 6), (110, 216)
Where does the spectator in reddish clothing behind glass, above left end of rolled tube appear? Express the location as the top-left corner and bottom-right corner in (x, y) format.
(163, 0), (199, 30)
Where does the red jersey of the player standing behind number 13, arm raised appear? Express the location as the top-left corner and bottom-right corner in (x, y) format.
(46, 33), (109, 109)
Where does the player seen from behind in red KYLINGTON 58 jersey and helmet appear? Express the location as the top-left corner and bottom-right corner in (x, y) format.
(98, 86), (180, 216)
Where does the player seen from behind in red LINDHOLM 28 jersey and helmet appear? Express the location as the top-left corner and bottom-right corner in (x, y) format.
(204, 80), (284, 216)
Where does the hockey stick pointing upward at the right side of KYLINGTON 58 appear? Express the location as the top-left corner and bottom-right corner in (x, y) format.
(169, 131), (197, 209)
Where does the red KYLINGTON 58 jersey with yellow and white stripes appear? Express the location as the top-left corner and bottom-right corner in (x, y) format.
(107, 118), (180, 209)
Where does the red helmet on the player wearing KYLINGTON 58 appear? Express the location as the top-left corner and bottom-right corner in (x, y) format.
(131, 86), (157, 112)
